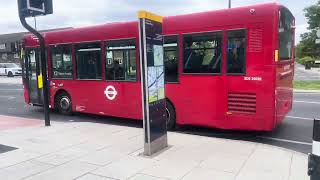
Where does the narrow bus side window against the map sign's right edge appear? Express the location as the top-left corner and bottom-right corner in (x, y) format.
(163, 36), (179, 82)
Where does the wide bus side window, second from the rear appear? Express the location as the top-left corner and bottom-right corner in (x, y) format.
(183, 32), (222, 74)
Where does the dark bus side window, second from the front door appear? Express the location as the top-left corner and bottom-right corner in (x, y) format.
(75, 42), (102, 79)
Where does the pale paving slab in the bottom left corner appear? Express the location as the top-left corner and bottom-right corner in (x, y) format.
(0, 160), (54, 180)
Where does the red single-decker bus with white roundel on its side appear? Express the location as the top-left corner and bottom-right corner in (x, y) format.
(23, 3), (294, 131)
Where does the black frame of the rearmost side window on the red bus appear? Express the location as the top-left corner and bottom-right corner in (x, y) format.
(224, 28), (248, 76)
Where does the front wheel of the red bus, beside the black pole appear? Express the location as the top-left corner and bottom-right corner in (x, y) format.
(55, 92), (72, 115)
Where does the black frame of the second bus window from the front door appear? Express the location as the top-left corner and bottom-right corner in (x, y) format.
(72, 40), (104, 81)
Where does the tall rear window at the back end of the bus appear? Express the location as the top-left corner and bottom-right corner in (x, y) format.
(279, 8), (294, 60)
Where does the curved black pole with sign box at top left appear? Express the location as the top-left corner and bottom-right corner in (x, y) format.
(18, 0), (53, 126)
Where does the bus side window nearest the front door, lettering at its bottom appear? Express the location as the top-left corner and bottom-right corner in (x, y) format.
(50, 45), (73, 79)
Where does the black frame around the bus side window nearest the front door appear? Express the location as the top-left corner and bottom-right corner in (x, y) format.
(47, 43), (76, 80)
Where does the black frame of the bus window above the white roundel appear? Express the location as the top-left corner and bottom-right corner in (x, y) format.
(102, 37), (136, 82)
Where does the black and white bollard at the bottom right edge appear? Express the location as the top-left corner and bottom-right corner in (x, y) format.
(308, 119), (320, 180)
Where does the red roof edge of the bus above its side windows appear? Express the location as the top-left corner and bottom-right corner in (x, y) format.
(24, 3), (284, 46)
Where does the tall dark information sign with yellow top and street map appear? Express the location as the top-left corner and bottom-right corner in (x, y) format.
(138, 11), (168, 156)
